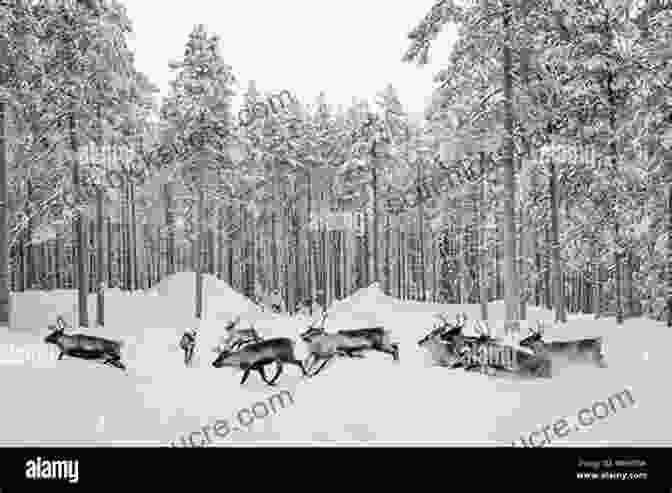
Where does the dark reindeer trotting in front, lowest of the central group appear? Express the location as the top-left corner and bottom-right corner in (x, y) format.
(212, 337), (307, 385)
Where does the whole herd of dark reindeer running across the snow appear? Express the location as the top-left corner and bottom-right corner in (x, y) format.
(44, 312), (606, 386)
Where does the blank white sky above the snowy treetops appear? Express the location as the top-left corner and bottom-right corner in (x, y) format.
(123, 0), (453, 117)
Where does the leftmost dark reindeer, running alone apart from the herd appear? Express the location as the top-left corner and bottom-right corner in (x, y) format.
(44, 315), (126, 371)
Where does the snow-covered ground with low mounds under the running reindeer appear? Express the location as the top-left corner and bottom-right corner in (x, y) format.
(0, 273), (672, 446)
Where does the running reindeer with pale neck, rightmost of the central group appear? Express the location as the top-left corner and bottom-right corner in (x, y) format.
(301, 312), (399, 376)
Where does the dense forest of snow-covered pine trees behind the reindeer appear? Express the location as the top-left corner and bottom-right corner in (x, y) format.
(0, 0), (672, 332)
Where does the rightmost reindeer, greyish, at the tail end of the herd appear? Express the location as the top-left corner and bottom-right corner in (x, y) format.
(520, 321), (607, 368)
